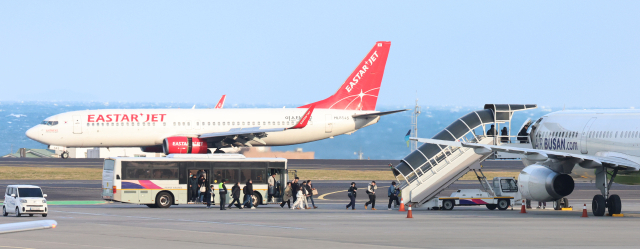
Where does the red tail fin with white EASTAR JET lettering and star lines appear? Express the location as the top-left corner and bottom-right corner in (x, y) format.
(299, 41), (391, 111)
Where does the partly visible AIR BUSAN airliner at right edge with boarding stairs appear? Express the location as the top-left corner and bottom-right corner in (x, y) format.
(416, 110), (640, 216)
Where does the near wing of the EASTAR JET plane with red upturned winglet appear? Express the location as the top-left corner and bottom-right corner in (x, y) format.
(199, 105), (315, 145)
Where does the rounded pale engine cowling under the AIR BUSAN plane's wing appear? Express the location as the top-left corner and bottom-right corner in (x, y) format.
(518, 165), (575, 201)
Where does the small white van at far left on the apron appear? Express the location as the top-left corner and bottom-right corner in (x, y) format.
(2, 185), (49, 217)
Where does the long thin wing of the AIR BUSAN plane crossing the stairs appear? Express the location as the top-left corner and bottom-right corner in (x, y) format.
(411, 138), (640, 171)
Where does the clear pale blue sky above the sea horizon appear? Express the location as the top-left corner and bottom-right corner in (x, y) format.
(0, 1), (640, 108)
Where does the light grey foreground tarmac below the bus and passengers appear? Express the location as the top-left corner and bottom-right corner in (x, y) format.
(0, 198), (640, 249)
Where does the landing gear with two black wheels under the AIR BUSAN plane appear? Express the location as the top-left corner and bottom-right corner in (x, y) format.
(591, 167), (622, 216)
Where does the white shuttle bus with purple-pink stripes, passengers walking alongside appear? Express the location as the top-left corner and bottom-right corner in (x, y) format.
(102, 154), (288, 208)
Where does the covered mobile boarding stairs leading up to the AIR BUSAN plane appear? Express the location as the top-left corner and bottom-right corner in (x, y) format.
(392, 104), (537, 207)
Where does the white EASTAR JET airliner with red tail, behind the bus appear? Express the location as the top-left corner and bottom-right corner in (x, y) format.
(26, 41), (404, 158)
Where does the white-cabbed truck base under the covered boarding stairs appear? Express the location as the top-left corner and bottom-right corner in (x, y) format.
(424, 170), (522, 210)
